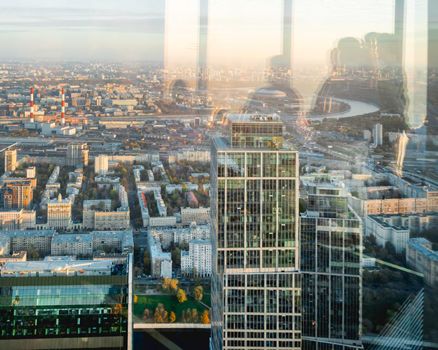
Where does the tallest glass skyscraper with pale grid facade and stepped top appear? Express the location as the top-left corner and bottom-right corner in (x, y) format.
(211, 114), (301, 349)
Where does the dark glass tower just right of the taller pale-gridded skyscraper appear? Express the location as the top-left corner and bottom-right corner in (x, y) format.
(301, 183), (362, 350)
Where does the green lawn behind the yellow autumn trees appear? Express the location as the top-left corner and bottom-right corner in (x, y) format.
(133, 294), (205, 322)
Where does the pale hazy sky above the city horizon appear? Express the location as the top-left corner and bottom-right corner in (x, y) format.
(0, 0), (394, 65)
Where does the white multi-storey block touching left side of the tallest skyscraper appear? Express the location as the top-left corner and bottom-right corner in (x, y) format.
(181, 240), (211, 278)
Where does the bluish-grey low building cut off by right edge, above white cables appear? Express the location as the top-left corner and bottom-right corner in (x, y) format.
(406, 237), (438, 286)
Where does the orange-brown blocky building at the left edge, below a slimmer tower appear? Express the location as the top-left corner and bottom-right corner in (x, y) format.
(1, 180), (33, 209)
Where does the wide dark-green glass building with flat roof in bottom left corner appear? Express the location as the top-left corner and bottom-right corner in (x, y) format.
(0, 255), (132, 350)
